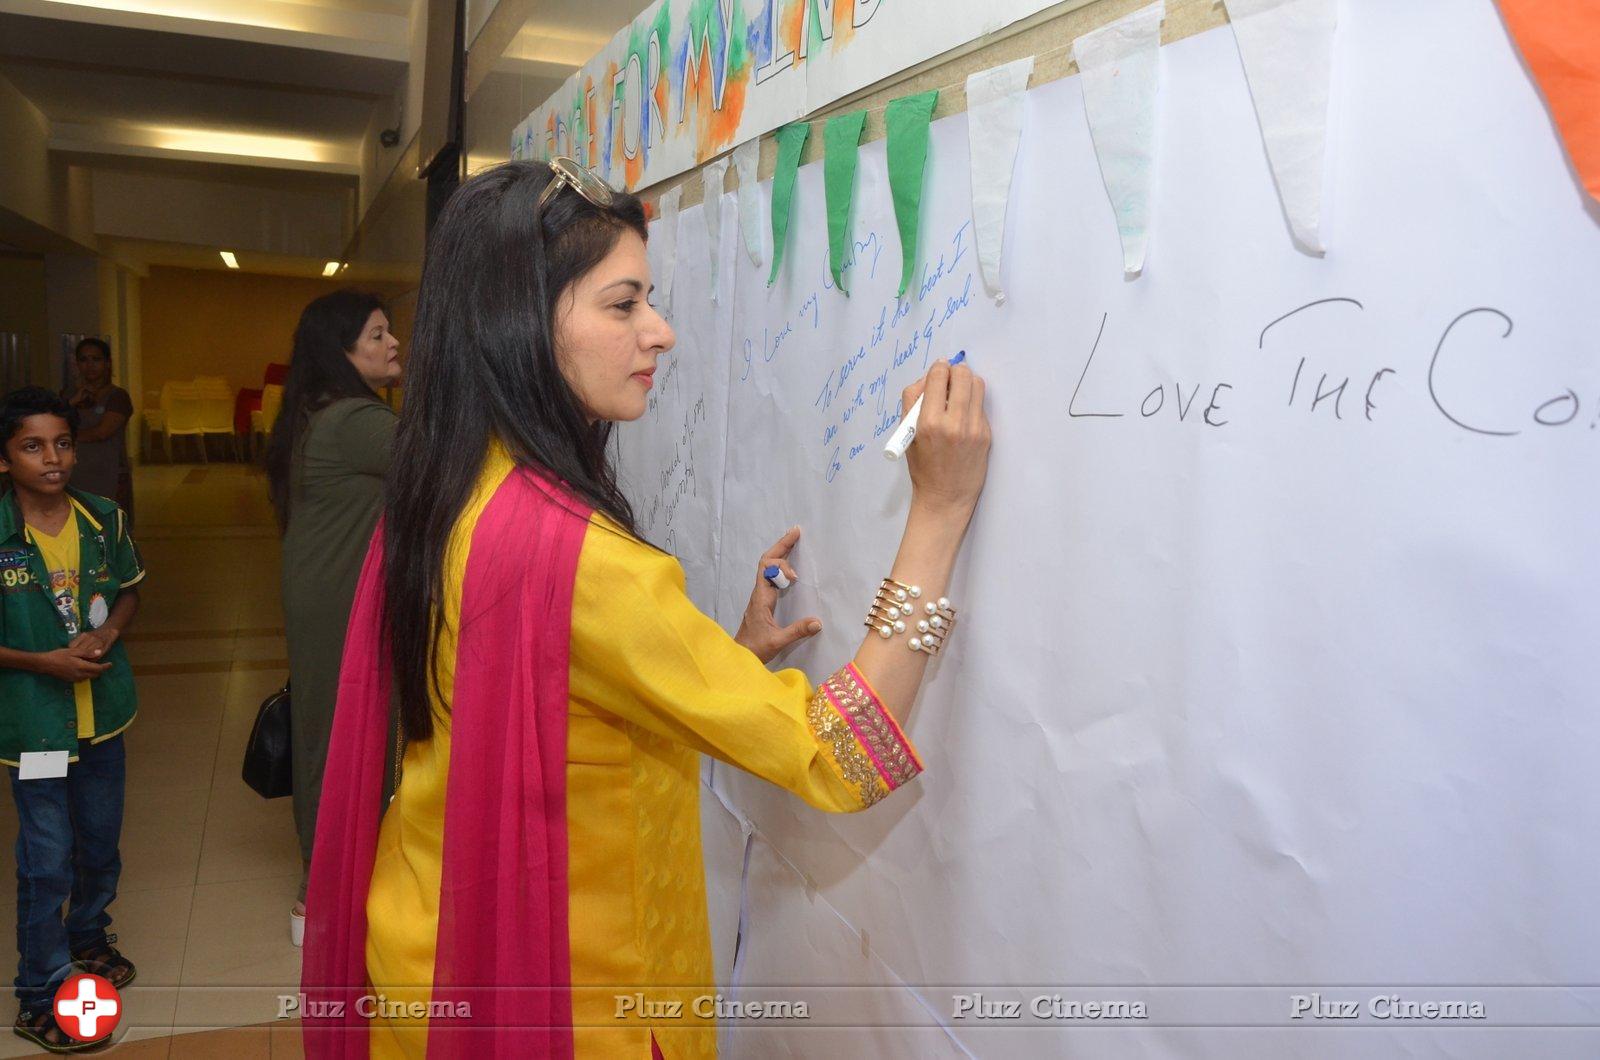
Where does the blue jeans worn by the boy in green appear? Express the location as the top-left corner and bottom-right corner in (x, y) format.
(10, 735), (128, 1009)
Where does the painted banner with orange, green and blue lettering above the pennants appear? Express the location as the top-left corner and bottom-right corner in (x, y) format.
(510, 0), (1051, 189)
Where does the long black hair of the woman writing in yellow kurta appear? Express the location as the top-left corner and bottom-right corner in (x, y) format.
(384, 162), (648, 740)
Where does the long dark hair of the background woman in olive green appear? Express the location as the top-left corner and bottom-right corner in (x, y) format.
(267, 290), (389, 530)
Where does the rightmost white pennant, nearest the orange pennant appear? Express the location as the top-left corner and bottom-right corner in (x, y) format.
(1226, 0), (1339, 255)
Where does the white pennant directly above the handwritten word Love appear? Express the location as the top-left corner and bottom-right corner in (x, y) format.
(1072, 2), (1165, 275)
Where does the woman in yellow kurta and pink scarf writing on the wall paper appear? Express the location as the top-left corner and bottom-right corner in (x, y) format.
(304, 160), (989, 1058)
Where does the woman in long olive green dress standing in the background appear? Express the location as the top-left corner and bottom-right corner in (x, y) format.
(267, 290), (400, 946)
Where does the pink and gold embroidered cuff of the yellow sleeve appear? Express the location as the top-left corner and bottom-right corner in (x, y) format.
(808, 663), (922, 807)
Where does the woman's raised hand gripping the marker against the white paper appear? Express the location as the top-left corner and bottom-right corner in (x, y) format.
(901, 360), (990, 517)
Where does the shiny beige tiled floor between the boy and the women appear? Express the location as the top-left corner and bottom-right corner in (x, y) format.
(0, 464), (299, 1060)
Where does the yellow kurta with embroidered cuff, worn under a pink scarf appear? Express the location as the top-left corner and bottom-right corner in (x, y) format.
(366, 447), (920, 1060)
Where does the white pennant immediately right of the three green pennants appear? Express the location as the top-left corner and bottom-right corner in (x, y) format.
(966, 56), (1034, 304)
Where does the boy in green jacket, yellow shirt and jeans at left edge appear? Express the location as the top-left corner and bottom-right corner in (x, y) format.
(0, 387), (144, 1052)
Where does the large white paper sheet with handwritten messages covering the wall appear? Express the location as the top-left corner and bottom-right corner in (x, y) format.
(619, 0), (1600, 1060)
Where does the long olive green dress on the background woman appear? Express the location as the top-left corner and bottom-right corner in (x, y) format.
(283, 397), (398, 900)
